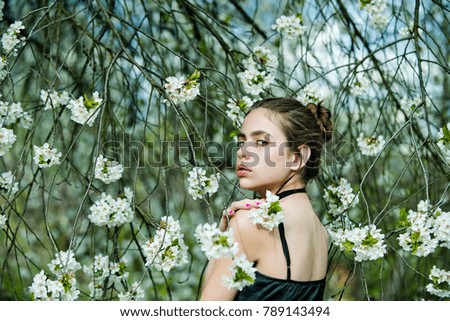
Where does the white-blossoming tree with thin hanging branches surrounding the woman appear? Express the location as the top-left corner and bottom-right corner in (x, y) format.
(0, 0), (450, 300)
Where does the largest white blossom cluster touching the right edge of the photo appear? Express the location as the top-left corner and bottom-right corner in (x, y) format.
(397, 200), (450, 257)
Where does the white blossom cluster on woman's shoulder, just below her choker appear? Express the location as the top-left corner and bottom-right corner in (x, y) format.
(248, 191), (284, 231)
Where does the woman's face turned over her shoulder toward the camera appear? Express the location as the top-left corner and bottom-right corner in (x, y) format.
(236, 108), (299, 197)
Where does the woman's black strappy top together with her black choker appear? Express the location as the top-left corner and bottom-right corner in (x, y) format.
(234, 188), (325, 301)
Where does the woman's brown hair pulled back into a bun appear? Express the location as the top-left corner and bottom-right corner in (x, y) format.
(250, 98), (333, 186)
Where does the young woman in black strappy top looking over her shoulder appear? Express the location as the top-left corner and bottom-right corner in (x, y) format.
(201, 98), (332, 301)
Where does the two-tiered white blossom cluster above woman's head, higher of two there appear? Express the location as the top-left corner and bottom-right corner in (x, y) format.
(237, 46), (278, 96)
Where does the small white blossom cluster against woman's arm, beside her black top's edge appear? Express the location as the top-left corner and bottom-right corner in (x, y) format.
(223, 254), (256, 291)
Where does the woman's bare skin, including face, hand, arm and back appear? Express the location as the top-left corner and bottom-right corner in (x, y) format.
(200, 110), (328, 300)
